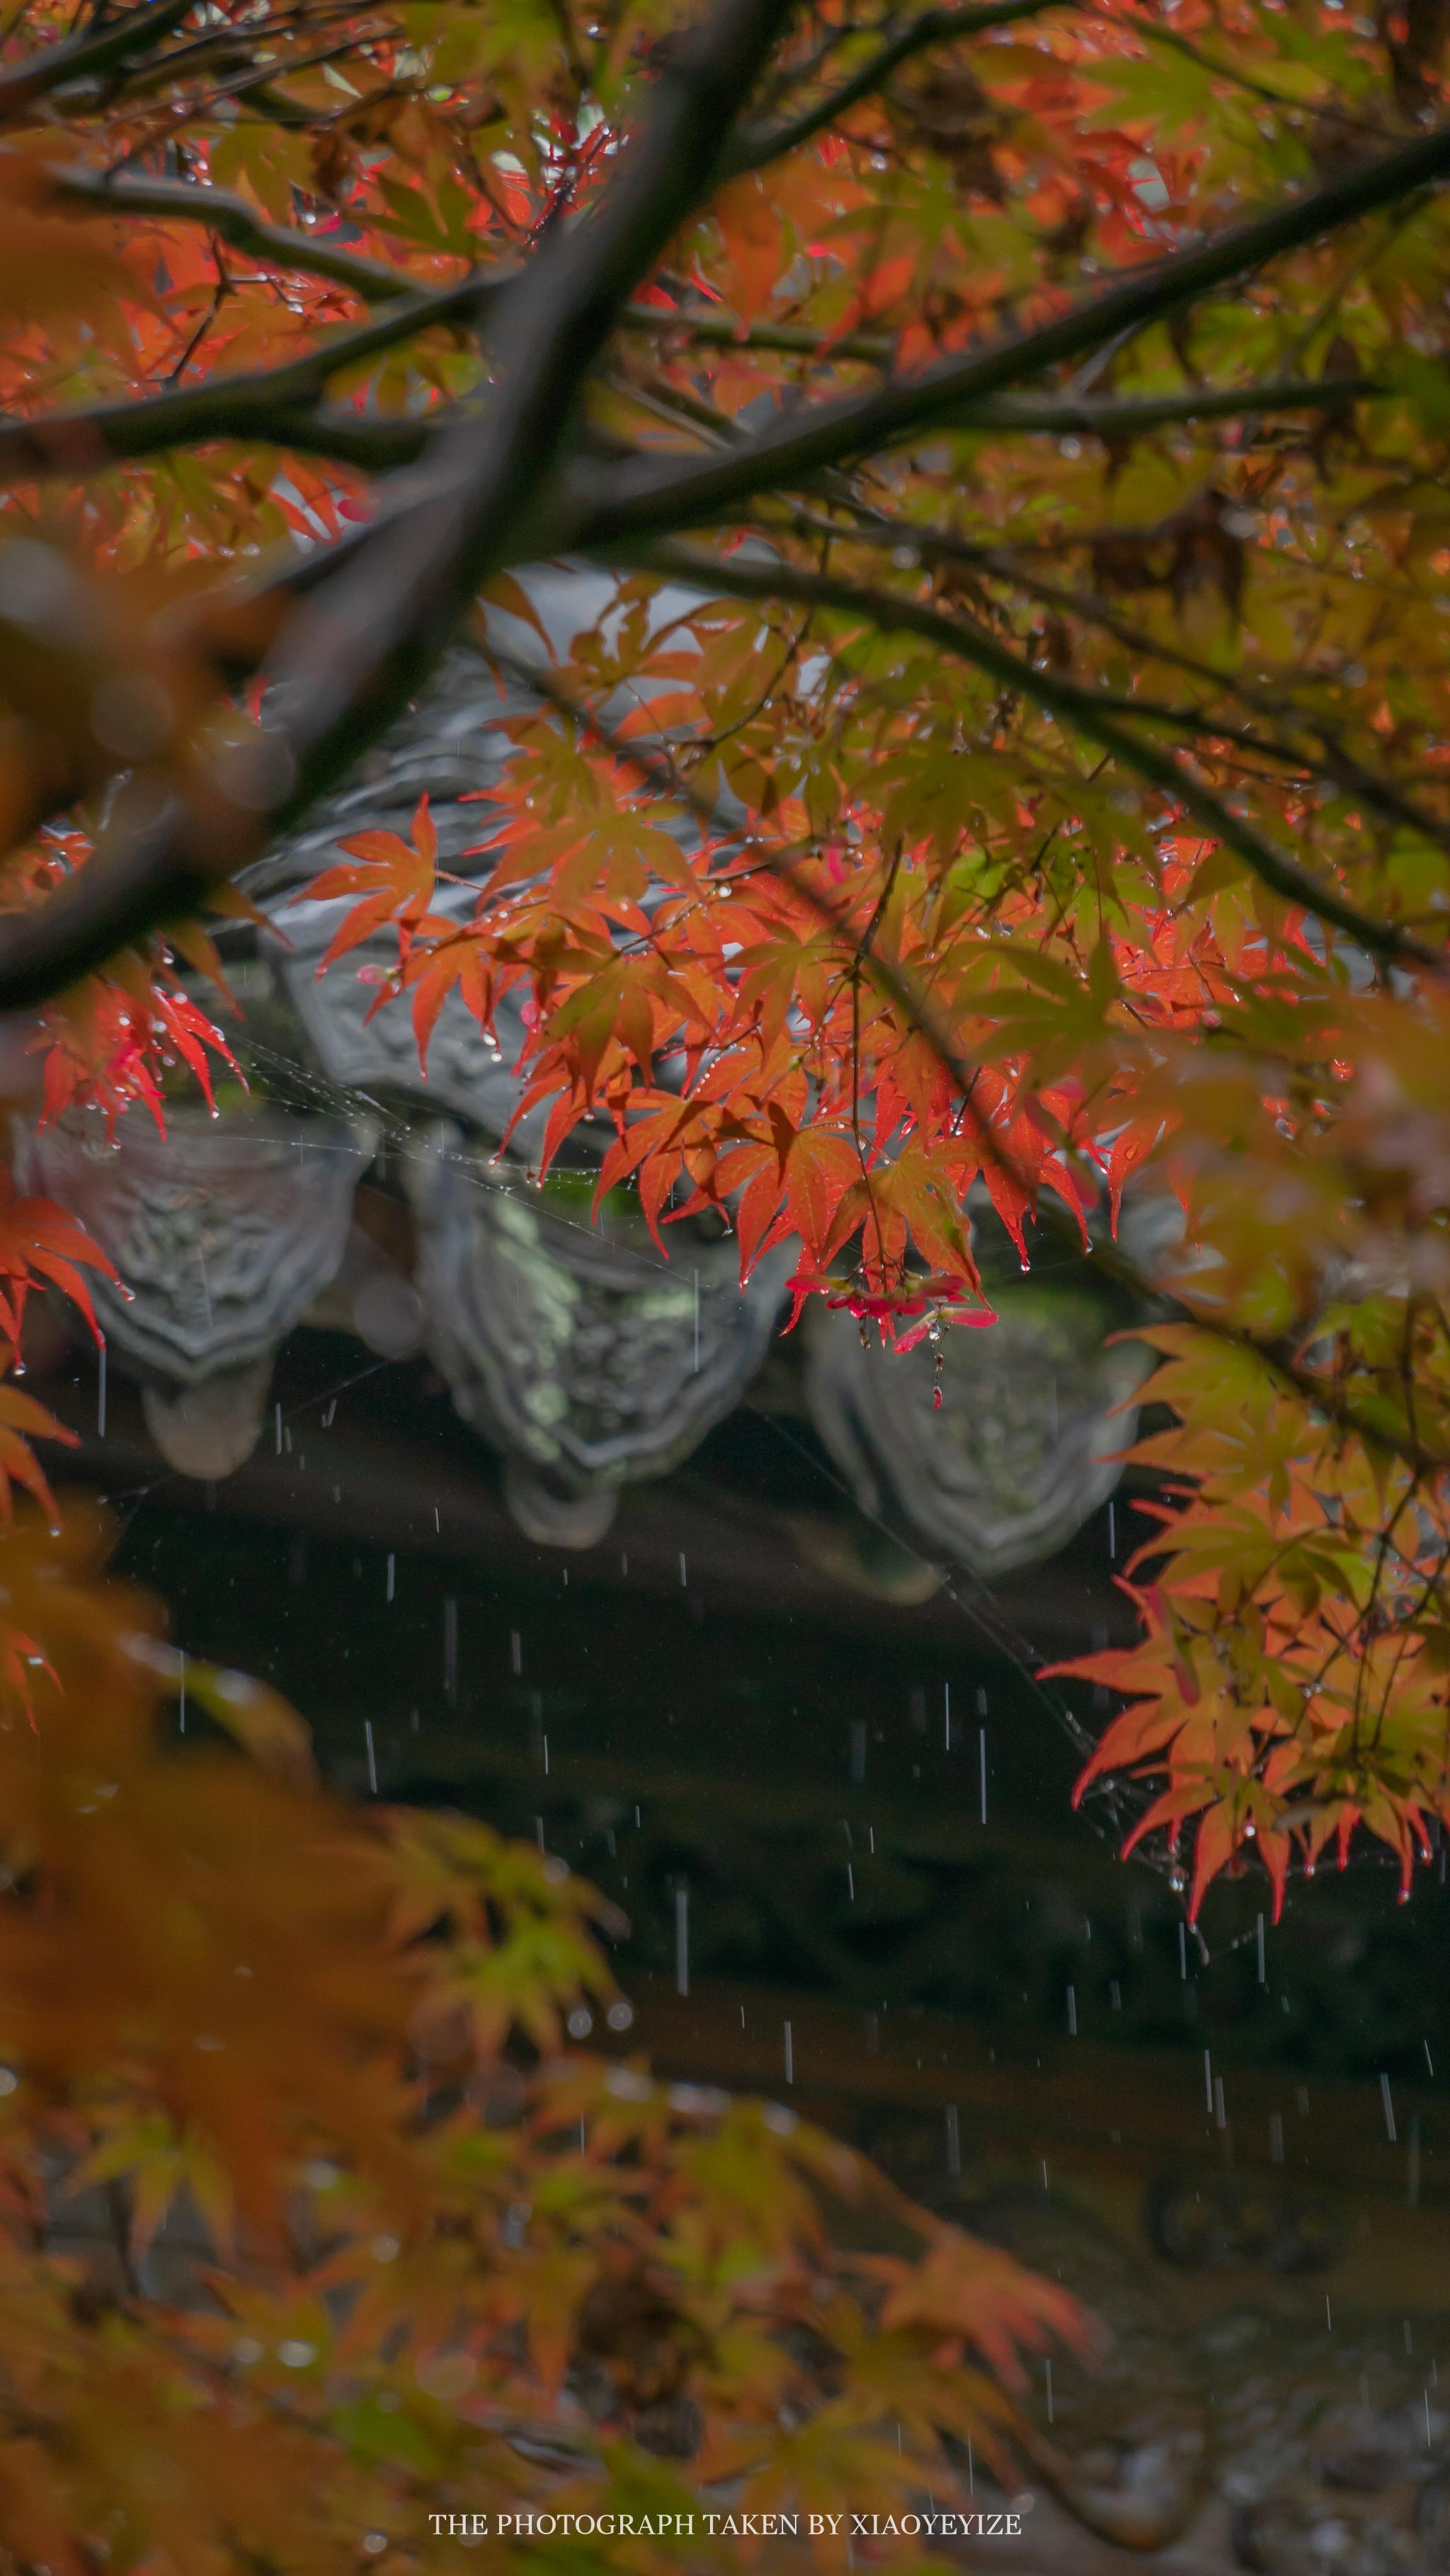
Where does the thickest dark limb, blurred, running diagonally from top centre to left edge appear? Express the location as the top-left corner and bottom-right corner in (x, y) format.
(0, 0), (791, 1010)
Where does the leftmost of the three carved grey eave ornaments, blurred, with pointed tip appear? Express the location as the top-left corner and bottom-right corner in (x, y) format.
(23, 1105), (373, 1476)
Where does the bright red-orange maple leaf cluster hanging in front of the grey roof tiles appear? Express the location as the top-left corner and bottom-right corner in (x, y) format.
(309, 762), (1112, 1345)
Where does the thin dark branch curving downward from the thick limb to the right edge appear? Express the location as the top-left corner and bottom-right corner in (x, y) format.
(615, 544), (1450, 976)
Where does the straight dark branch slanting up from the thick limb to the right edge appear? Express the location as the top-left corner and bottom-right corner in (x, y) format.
(585, 126), (1450, 546)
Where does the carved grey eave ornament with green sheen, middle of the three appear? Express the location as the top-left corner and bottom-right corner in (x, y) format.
(409, 1128), (783, 1548)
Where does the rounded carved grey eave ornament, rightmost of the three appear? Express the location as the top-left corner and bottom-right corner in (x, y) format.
(806, 1275), (1151, 1576)
